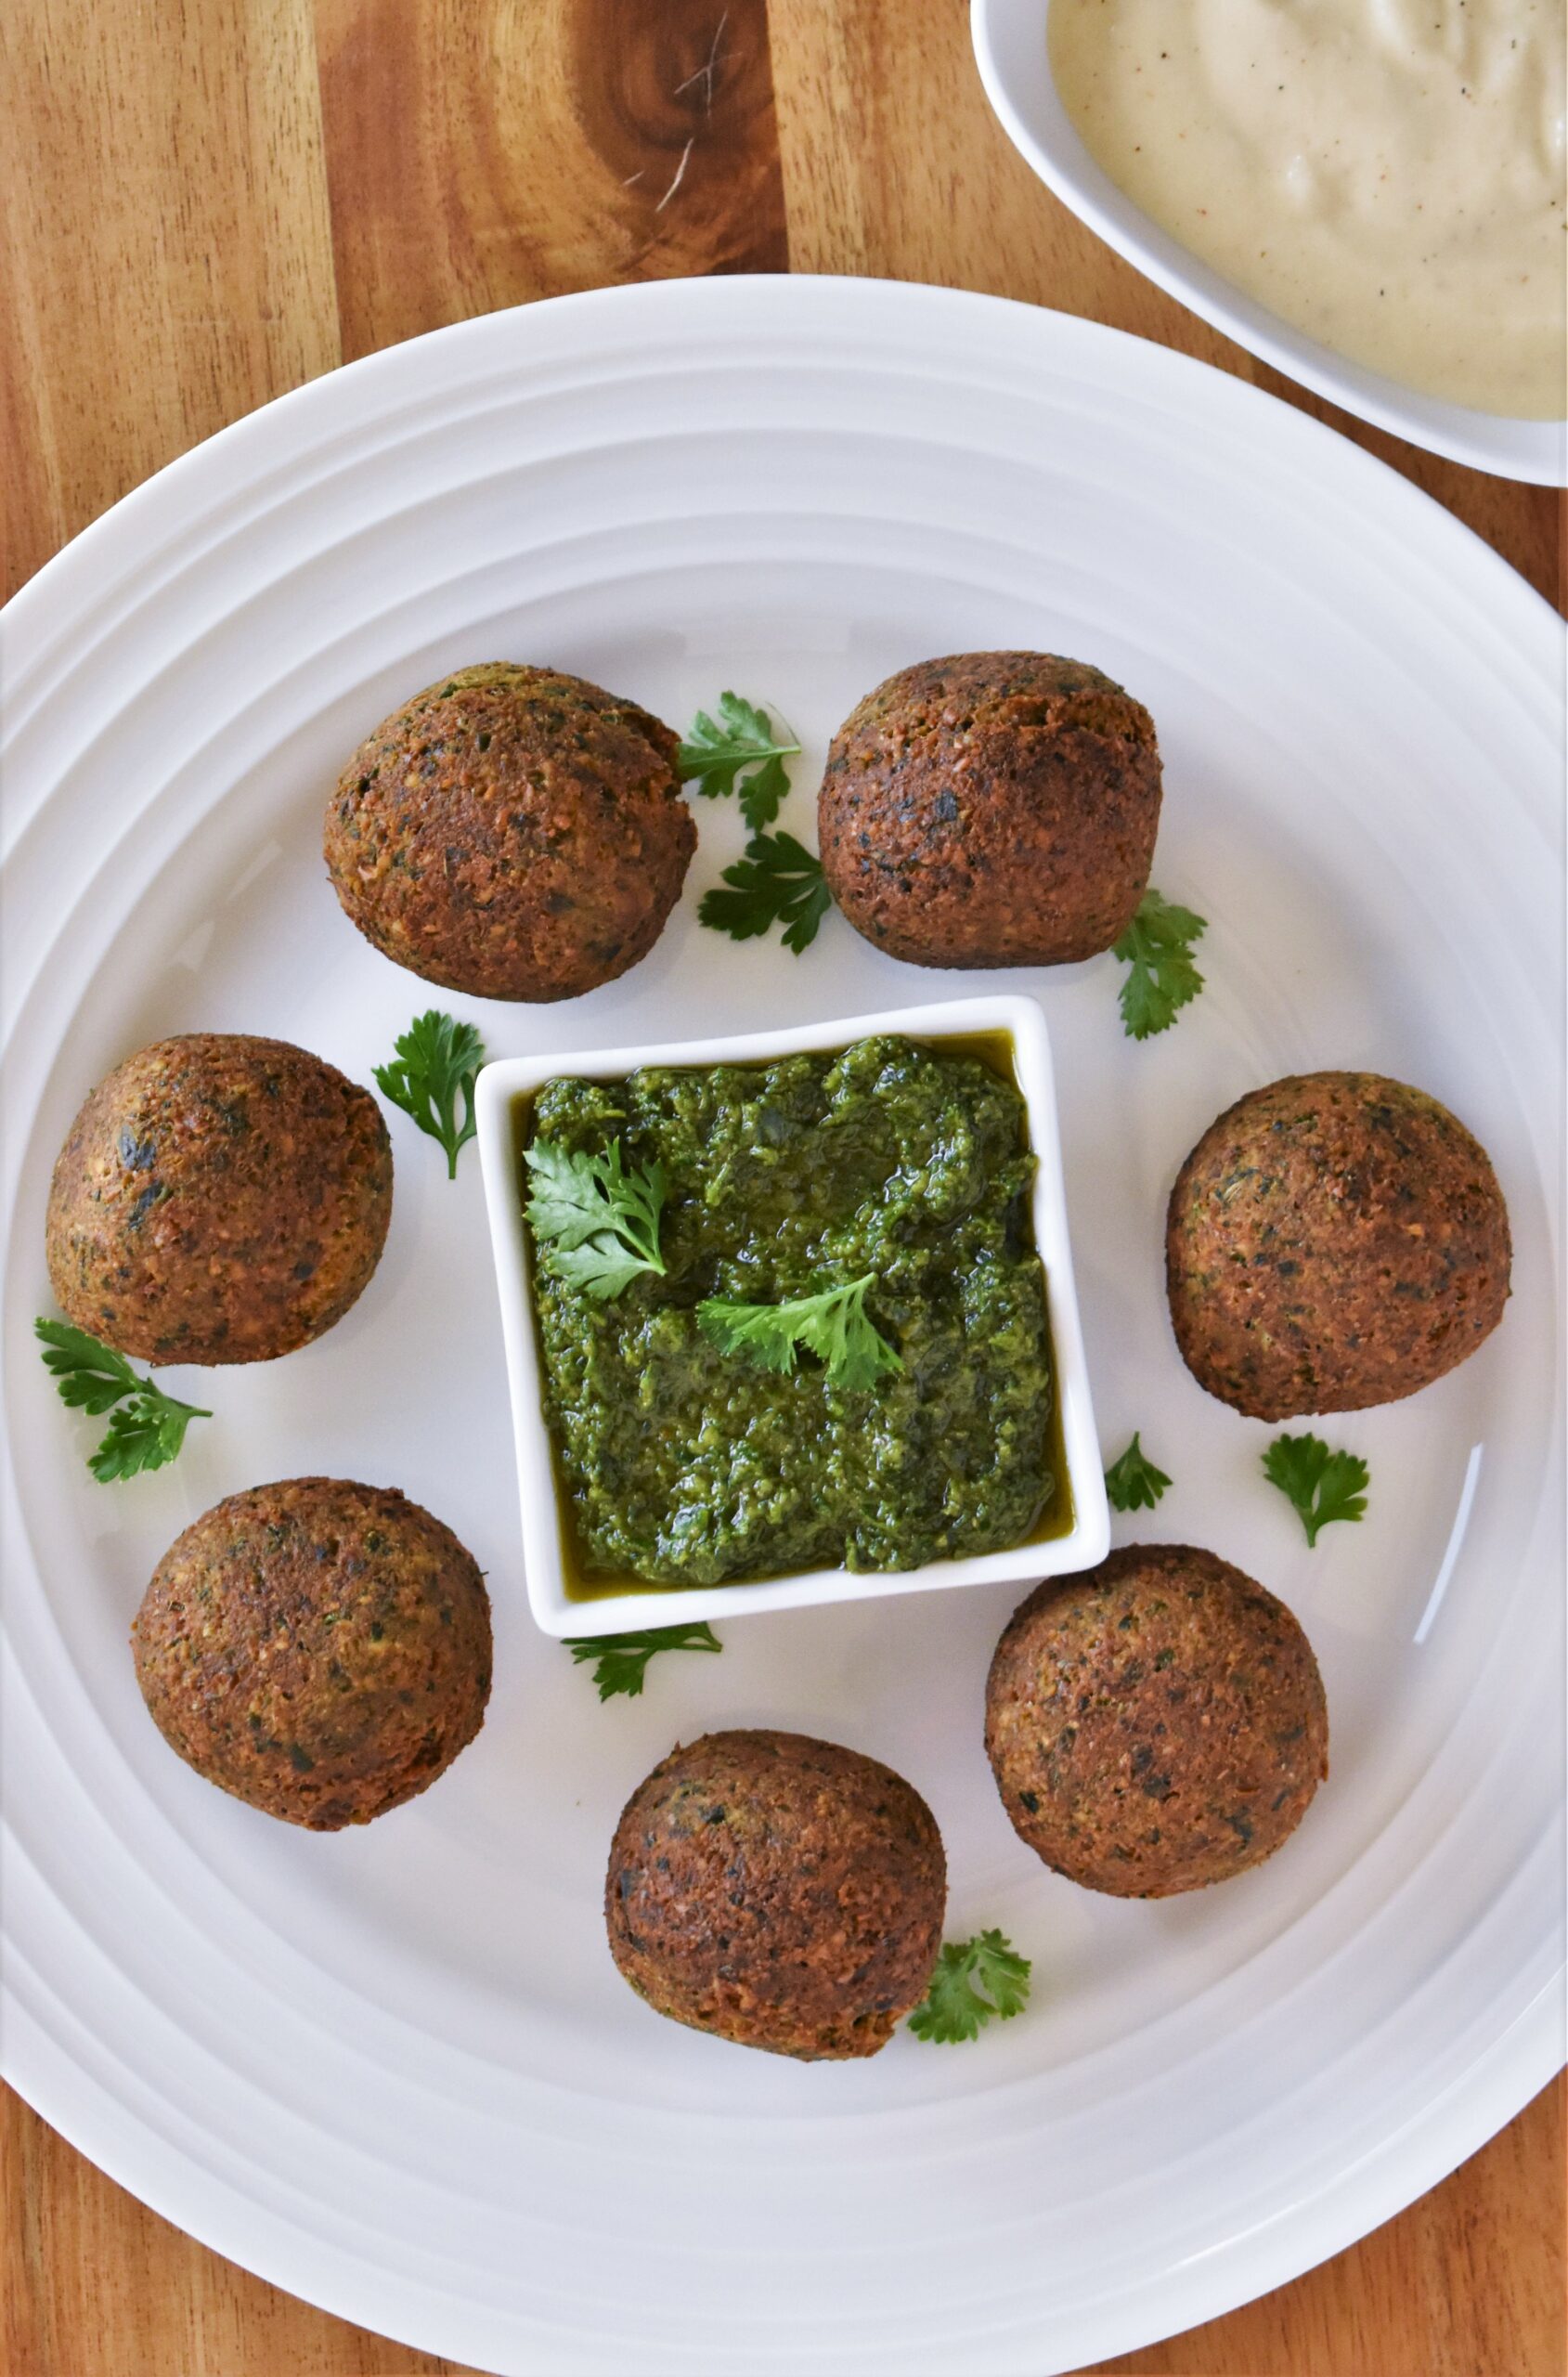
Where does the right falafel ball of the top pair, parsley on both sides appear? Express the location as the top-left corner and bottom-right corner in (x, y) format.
(817, 651), (1160, 965)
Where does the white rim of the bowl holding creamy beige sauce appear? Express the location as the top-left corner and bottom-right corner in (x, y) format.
(969, 0), (1568, 487)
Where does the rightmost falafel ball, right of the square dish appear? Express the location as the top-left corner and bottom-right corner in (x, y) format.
(1164, 1072), (1511, 1419)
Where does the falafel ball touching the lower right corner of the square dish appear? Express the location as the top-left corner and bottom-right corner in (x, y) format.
(986, 1542), (1328, 1899)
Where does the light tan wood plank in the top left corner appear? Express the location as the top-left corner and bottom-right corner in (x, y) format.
(0, 0), (340, 591)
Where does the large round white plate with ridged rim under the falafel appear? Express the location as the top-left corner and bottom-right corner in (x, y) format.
(3, 280), (1563, 2377)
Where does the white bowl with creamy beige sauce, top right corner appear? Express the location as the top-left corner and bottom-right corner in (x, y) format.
(972, 0), (1568, 485)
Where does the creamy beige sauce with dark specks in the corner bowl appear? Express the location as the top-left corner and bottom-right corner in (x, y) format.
(1050, 0), (1568, 421)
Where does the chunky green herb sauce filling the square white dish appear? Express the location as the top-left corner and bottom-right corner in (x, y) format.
(525, 1034), (1057, 1588)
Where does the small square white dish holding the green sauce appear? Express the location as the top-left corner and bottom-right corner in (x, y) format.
(475, 996), (1109, 1635)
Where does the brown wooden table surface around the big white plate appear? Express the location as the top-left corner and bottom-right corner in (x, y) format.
(0, 0), (1565, 2377)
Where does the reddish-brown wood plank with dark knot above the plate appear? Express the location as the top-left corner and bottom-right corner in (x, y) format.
(316, 0), (786, 354)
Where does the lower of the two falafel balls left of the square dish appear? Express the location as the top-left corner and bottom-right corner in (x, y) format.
(131, 1478), (489, 1833)
